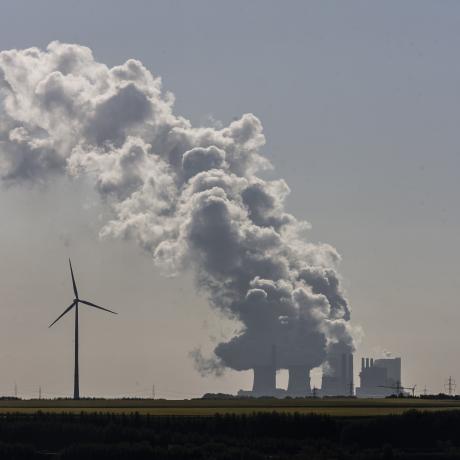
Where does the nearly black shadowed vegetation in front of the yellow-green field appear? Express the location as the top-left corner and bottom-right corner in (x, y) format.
(0, 411), (460, 460)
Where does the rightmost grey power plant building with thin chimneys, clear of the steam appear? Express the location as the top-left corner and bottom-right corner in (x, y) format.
(356, 358), (401, 398)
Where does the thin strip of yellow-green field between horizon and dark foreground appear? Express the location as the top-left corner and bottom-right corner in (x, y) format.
(0, 398), (460, 417)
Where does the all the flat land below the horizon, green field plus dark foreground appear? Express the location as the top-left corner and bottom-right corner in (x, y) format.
(0, 398), (460, 460)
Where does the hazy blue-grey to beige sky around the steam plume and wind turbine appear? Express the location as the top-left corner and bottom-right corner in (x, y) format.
(0, 0), (460, 398)
